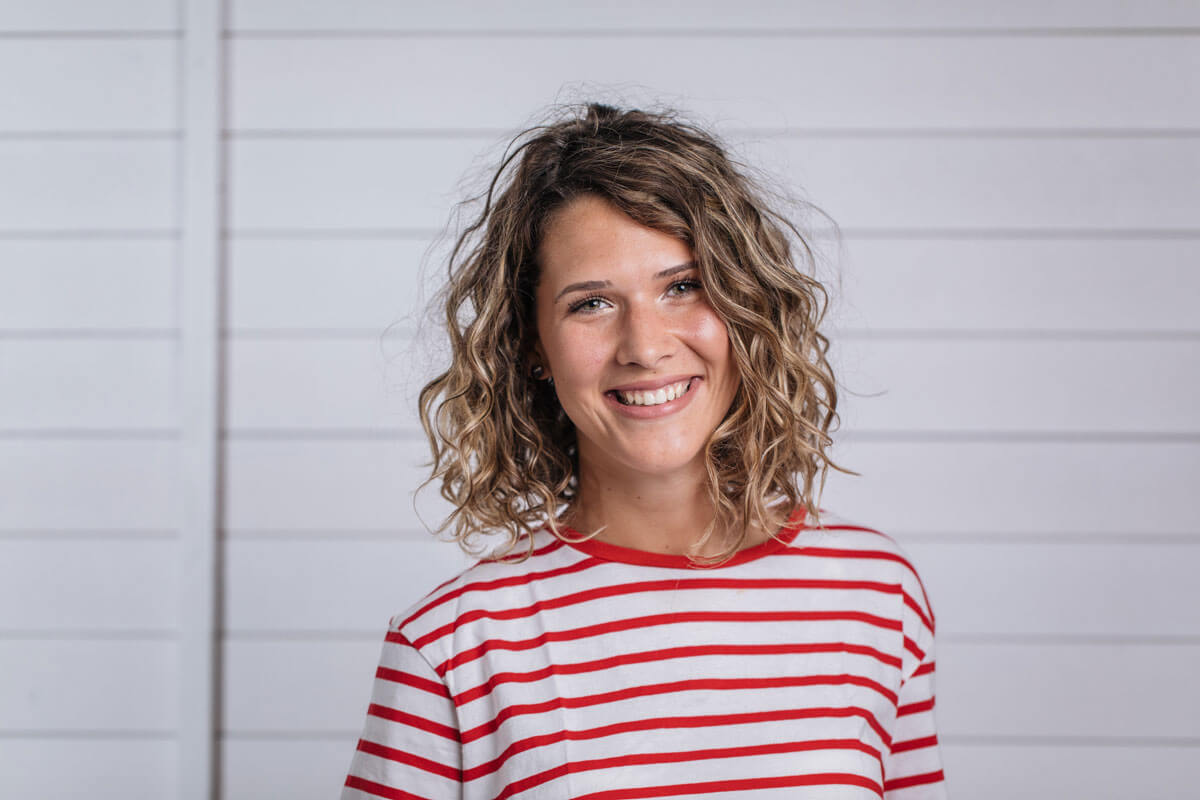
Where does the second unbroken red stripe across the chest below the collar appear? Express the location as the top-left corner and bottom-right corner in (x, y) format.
(434, 610), (904, 675)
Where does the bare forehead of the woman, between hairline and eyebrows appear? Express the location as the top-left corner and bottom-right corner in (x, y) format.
(538, 194), (692, 283)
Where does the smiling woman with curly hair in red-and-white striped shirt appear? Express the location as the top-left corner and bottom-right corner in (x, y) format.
(342, 104), (944, 800)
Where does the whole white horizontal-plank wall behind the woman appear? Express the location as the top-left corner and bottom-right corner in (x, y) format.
(0, 0), (1200, 800)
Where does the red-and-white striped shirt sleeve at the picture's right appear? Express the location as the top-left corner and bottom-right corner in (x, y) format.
(883, 561), (947, 800)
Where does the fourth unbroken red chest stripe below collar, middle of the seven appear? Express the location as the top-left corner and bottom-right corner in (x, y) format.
(462, 674), (896, 744)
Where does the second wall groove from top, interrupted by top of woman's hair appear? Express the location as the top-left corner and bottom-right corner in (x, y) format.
(222, 126), (1200, 142)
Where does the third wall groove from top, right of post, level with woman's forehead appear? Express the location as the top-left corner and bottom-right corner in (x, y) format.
(223, 227), (1200, 241)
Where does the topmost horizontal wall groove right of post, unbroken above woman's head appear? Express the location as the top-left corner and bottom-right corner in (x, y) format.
(224, 25), (1200, 41)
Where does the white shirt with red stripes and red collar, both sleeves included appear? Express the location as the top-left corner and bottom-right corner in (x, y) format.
(342, 509), (946, 800)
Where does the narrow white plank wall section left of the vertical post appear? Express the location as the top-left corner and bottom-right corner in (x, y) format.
(0, 0), (180, 799)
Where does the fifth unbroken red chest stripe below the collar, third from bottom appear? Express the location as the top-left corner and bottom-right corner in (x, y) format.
(463, 706), (892, 781)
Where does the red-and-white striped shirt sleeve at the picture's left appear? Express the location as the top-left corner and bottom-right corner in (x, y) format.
(342, 626), (462, 800)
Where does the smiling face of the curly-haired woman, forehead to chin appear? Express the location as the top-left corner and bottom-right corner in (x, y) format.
(536, 196), (739, 489)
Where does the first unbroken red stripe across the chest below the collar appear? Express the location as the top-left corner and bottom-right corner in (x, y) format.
(413, 578), (901, 649)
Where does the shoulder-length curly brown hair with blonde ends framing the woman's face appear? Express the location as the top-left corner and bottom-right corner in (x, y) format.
(419, 103), (850, 566)
